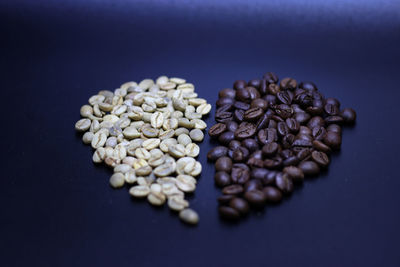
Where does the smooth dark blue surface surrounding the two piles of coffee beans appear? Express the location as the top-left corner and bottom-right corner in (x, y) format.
(0, 0), (400, 266)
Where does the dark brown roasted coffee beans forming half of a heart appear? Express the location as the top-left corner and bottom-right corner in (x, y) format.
(207, 72), (356, 220)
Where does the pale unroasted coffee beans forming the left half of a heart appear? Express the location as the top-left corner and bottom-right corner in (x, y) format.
(75, 76), (211, 224)
